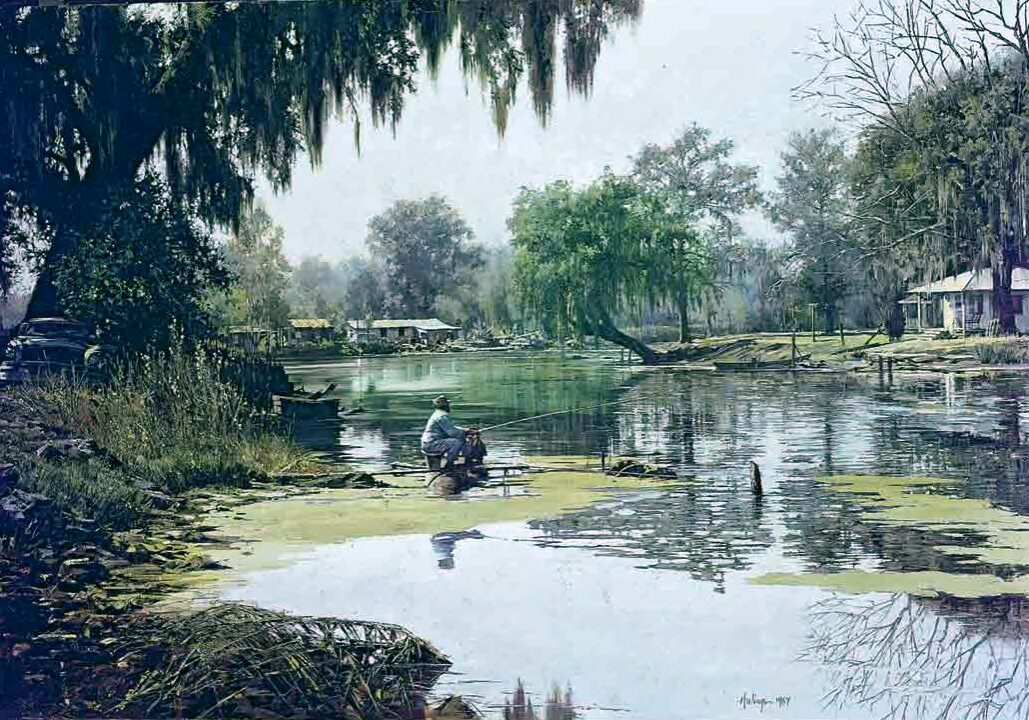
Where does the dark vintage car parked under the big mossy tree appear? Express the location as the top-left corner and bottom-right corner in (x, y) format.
(0, 318), (104, 386)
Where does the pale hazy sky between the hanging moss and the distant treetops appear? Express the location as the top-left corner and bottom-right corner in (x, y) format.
(259, 0), (855, 260)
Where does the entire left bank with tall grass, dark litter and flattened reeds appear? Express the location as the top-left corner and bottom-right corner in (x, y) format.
(0, 347), (446, 717)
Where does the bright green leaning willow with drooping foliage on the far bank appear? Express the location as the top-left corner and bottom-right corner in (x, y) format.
(508, 174), (695, 364)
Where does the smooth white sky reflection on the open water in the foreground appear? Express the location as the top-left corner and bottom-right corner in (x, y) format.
(228, 524), (866, 718)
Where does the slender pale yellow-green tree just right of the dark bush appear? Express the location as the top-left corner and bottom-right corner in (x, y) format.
(223, 199), (290, 330)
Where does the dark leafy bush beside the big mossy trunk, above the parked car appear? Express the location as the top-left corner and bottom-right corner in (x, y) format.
(55, 174), (229, 353)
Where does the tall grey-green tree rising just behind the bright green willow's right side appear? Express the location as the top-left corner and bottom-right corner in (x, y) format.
(633, 123), (759, 343)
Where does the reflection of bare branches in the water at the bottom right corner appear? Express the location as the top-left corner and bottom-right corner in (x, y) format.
(804, 595), (1029, 720)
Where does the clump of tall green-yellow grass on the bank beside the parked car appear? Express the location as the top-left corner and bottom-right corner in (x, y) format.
(19, 352), (308, 493)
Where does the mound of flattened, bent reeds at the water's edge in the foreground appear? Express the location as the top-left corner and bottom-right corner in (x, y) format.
(109, 605), (450, 719)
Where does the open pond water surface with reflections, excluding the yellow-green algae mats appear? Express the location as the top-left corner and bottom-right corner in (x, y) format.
(223, 354), (1029, 719)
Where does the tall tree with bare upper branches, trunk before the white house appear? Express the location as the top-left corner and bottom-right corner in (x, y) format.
(795, 0), (1029, 333)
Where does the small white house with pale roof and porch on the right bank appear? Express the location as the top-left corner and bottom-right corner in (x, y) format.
(900, 267), (1029, 333)
